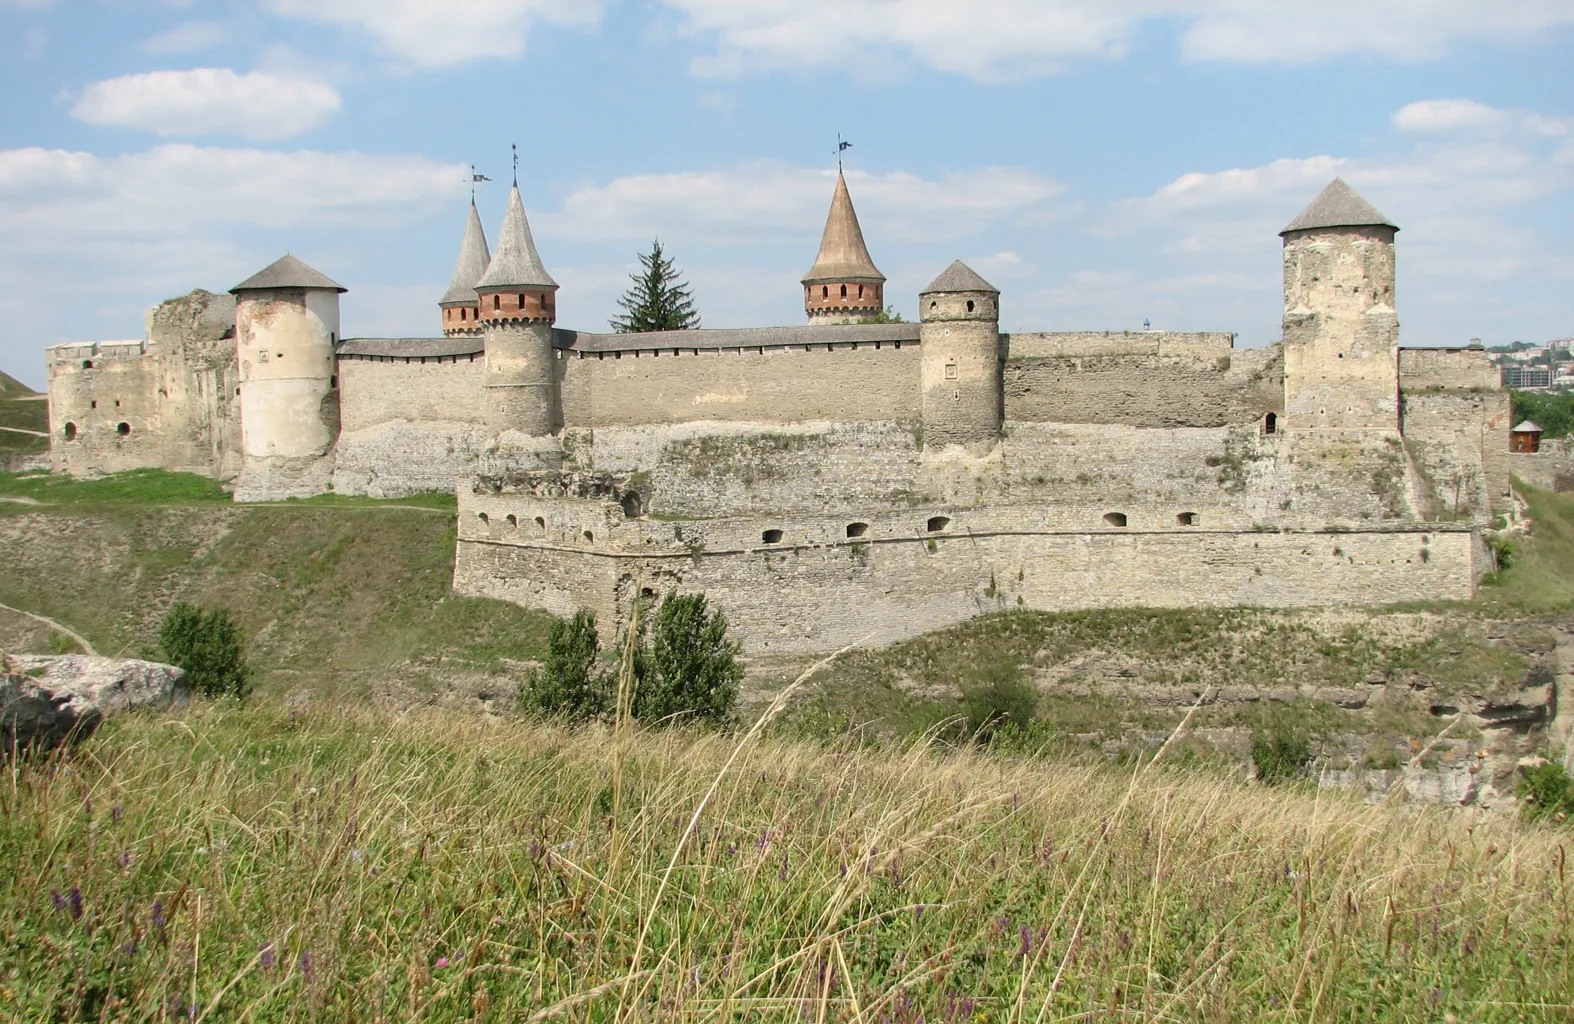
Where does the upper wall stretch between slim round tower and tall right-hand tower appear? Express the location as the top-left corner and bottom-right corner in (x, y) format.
(1003, 342), (1284, 426)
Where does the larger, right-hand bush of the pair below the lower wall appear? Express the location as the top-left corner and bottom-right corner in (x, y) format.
(634, 595), (743, 724)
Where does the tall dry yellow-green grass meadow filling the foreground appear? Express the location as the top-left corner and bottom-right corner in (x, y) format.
(0, 703), (1574, 1024)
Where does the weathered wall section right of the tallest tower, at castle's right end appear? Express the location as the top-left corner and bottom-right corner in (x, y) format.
(1402, 390), (1509, 525)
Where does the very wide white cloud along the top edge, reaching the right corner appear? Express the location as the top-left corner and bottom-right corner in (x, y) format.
(664, 0), (1574, 79)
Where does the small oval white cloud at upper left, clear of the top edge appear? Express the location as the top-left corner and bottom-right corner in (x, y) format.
(71, 68), (340, 138)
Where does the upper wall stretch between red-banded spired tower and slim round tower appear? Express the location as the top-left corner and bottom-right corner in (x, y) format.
(559, 341), (919, 428)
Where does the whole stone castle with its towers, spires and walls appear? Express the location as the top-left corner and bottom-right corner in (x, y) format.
(49, 176), (1519, 654)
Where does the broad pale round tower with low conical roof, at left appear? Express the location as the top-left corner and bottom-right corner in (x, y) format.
(230, 256), (345, 500)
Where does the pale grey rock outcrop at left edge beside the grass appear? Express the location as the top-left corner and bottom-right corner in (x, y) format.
(0, 654), (190, 755)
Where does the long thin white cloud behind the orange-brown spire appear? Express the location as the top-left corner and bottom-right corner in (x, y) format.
(540, 162), (1064, 242)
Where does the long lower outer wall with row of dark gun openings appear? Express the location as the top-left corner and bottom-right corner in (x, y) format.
(455, 491), (1483, 653)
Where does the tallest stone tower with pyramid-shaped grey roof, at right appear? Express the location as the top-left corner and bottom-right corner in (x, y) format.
(1280, 178), (1399, 431)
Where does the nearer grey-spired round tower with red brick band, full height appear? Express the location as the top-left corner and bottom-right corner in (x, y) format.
(475, 184), (557, 437)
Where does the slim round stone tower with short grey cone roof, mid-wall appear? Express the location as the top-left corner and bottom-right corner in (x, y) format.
(918, 260), (1001, 455)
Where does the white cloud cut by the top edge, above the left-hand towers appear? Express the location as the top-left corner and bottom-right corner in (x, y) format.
(263, 0), (606, 68)
